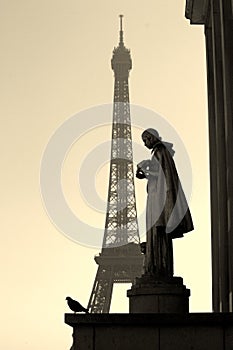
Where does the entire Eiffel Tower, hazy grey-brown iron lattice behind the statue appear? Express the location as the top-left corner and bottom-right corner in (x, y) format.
(88, 15), (143, 313)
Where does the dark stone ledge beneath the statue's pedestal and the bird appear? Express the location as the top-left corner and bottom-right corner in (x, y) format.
(65, 313), (233, 350)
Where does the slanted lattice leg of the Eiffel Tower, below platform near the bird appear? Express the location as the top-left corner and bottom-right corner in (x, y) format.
(88, 266), (113, 313)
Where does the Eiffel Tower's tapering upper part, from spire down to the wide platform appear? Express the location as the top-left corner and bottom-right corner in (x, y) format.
(103, 15), (139, 249)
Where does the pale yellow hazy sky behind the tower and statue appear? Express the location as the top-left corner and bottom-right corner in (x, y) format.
(0, 0), (211, 350)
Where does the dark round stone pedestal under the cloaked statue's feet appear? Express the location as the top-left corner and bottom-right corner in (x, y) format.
(127, 275), (190, 314)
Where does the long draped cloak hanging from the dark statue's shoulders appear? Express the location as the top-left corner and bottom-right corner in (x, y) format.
(146, 141), (193, 238)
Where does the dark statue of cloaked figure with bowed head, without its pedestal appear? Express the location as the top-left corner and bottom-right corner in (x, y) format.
(136, 129), (193, 278)
